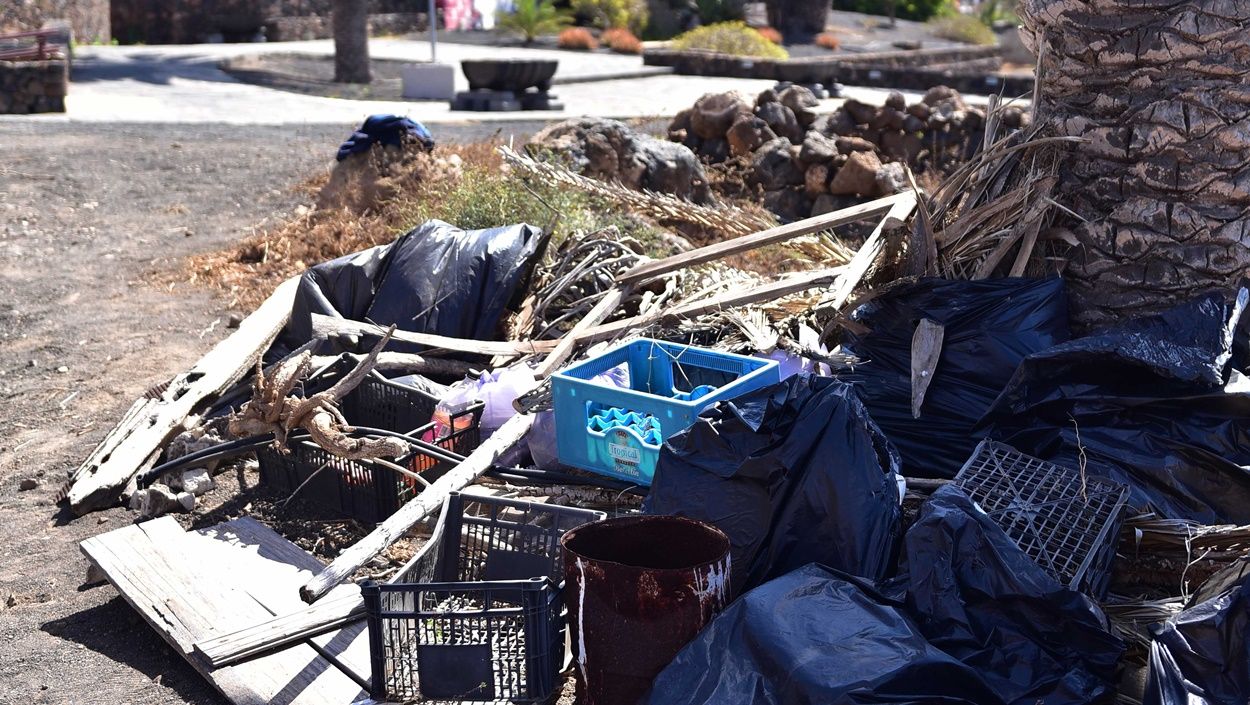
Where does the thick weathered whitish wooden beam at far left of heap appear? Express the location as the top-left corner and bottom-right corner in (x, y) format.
(66, 276), (299, 515)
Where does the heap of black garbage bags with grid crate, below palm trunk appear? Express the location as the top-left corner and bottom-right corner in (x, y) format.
(644, 279), (1250, 705)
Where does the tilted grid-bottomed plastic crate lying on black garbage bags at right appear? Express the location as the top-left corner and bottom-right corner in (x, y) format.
(955, 440), (1129, 599)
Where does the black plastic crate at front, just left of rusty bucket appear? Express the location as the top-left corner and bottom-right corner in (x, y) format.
(364, 493), (605, 703)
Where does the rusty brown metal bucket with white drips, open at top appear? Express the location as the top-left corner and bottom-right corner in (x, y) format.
(560, 516), (729, 705)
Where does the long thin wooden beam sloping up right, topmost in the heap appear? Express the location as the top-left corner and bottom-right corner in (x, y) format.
(616, 194), (915, 284)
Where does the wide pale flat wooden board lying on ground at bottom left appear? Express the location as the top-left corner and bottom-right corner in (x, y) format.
(81, 516), (369, 705)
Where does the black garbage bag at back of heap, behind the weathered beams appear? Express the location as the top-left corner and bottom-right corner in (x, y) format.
(281, 220), (543, 349)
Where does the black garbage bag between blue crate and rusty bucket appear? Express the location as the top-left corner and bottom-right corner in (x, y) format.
(644, 375), (900, 594)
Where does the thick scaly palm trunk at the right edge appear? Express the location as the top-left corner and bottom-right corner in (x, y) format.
(1019, 0), (1250, 326)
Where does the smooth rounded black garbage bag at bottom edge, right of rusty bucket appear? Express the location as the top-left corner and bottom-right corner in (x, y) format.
(645, 565), (1003, 705)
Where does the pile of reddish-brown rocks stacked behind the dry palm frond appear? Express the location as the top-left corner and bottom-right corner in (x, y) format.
(669, 84), (1028, 220)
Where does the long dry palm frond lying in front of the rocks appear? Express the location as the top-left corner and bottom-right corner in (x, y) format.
(499, 146), (776, 238)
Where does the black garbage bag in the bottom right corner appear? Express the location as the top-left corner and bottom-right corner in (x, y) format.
(1143, 567), (1250, 705)
